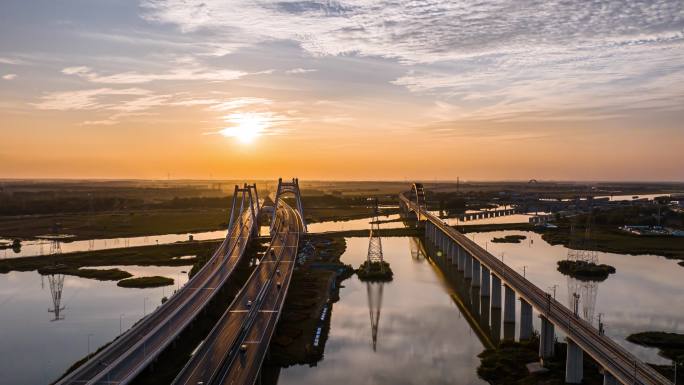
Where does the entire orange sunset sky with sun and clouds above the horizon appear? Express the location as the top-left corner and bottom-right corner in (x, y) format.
(0, 0), (684, 181)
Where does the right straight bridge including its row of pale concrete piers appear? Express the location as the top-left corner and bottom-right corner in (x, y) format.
(399, 183), (671, 385)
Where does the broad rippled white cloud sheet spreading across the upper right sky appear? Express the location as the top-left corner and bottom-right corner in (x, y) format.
(142, 0), (684, 120)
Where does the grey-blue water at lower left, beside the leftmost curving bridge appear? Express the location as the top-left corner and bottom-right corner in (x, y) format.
(0, 266), (188, 385)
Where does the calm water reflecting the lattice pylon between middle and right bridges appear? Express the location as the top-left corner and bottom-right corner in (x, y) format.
(279, 238), (484, 384)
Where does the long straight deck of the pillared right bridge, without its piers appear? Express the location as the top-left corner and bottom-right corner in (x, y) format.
(400, 194), (671, 385)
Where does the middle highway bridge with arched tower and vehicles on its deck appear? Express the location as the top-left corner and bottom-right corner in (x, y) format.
(173, 179), (306, 385)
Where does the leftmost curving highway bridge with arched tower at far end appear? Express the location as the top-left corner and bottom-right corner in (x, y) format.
(57, 184), (260, 385)
